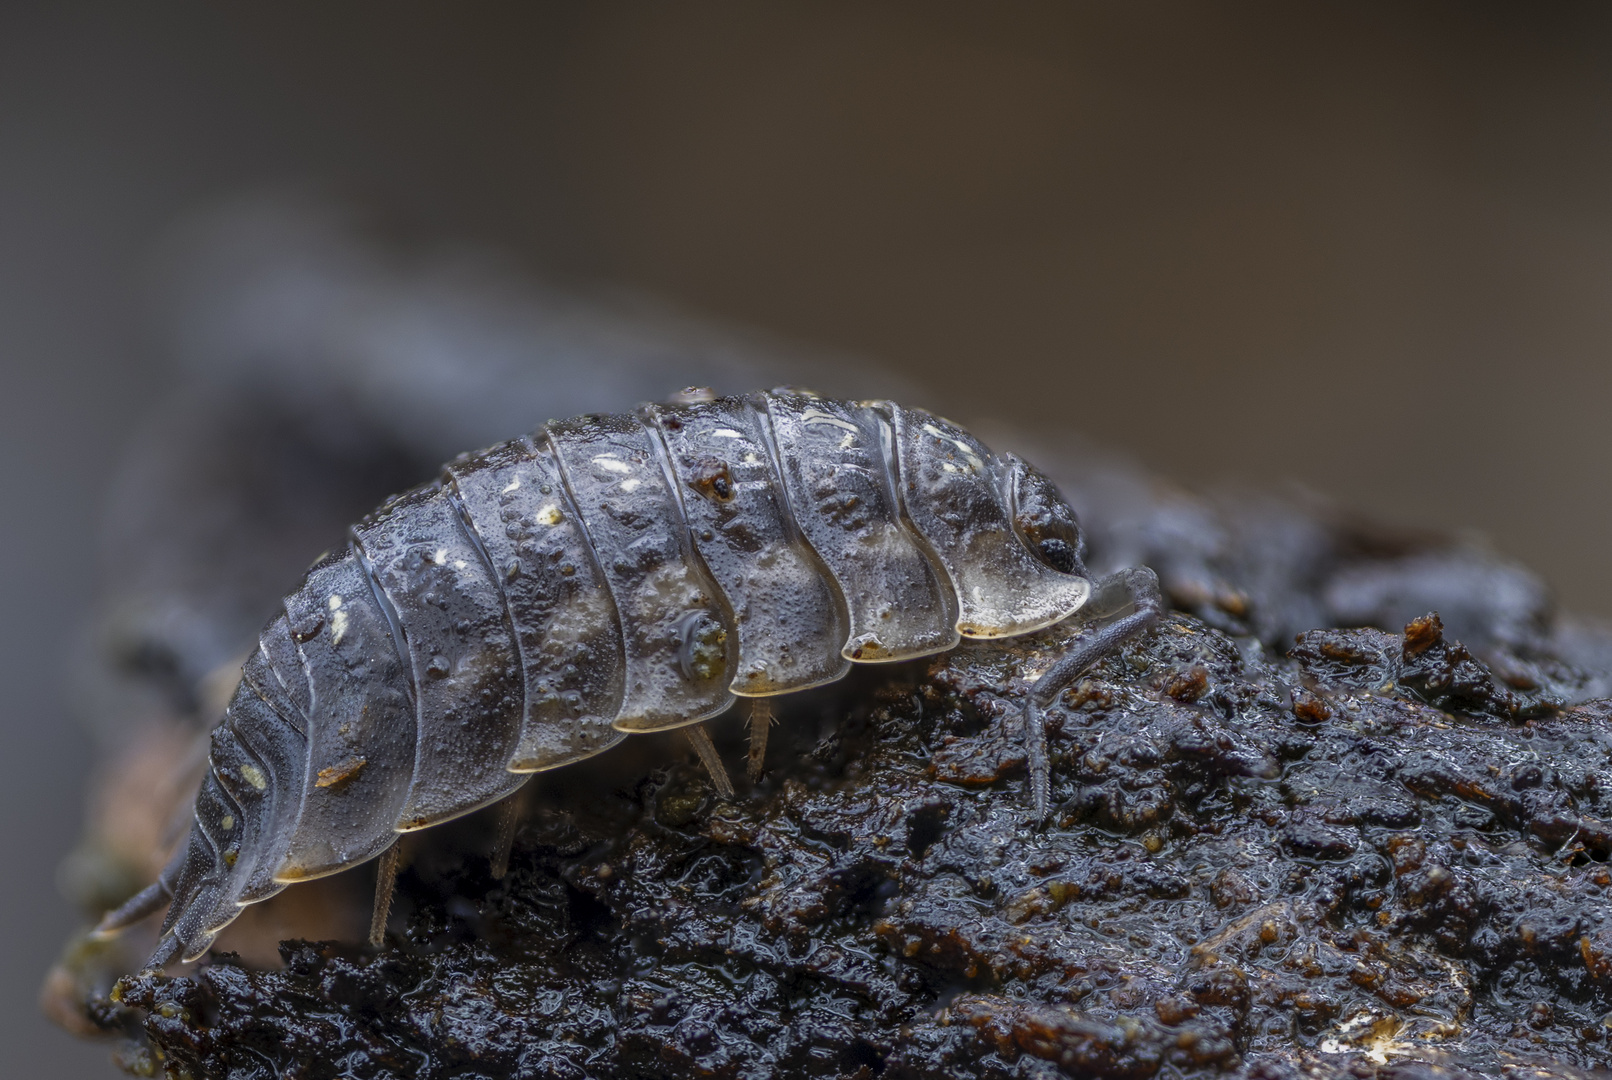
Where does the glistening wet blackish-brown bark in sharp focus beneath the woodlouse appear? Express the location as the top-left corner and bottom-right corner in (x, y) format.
(89, 614), (1612, 1080)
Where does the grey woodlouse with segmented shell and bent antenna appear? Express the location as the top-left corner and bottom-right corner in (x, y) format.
(102, 390), (1159, 964)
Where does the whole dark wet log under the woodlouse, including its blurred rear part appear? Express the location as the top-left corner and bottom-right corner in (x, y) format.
(45, 205), (1612, 1080)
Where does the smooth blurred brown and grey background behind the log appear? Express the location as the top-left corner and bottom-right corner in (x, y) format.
(9, 0), (1612, 1077)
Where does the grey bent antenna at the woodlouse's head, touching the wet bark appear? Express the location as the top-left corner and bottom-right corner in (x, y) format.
(1024, 566), (1164, 822)
